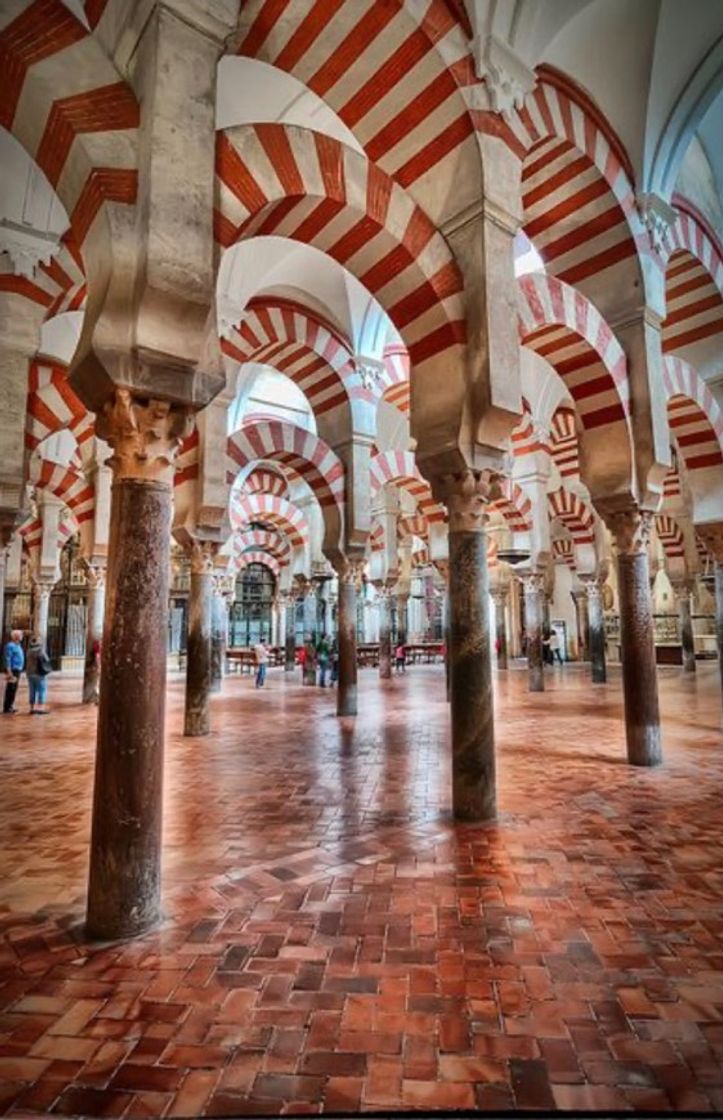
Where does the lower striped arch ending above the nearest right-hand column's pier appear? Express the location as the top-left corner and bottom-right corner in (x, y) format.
(518, 273), (630, 431)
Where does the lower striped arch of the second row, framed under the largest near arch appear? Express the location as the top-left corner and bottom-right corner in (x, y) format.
(226, 420), (344, 516)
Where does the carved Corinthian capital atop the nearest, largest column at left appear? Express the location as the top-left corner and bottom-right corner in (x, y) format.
(95, 389), (194, 486)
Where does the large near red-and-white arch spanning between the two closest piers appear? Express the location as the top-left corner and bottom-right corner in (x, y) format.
(215, 124), (464, 366)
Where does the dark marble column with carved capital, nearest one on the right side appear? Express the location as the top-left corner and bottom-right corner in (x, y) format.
(608, 510), (663, 766)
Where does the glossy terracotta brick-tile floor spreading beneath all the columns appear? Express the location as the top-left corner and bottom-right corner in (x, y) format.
(0, 664), (723, 1117)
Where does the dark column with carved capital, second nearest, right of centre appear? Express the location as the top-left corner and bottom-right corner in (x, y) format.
(434, 470), (497, 821)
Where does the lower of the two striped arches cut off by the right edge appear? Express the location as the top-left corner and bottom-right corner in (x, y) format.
(663, 354), (723, 470)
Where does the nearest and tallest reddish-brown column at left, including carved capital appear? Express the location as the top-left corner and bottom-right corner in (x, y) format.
(86, 389), (190, 941)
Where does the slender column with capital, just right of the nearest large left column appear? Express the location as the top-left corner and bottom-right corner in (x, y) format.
(184, 540), (216, 737)
